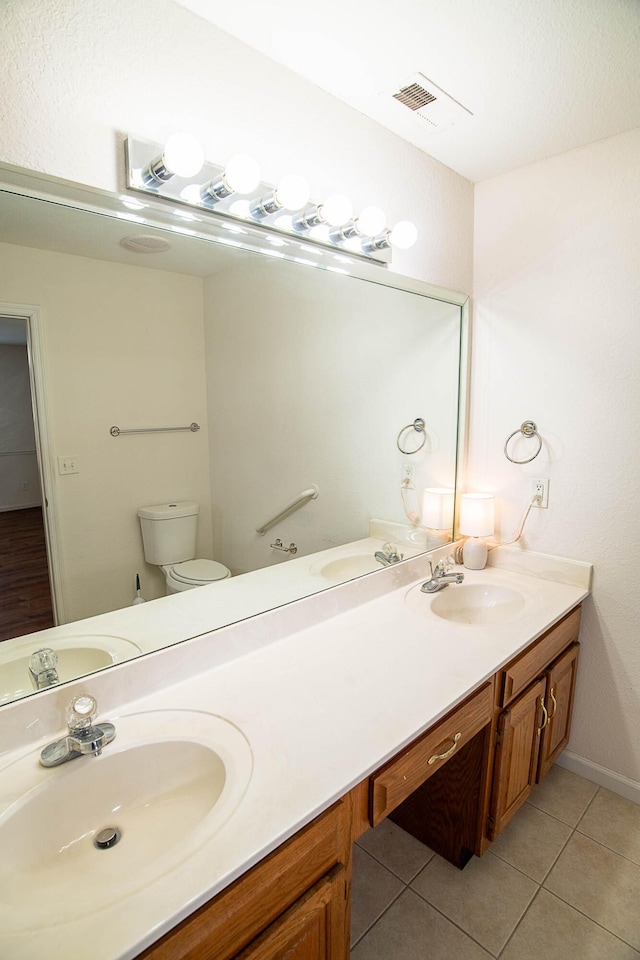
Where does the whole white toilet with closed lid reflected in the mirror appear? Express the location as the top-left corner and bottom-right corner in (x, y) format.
(138, 500), (231, 596)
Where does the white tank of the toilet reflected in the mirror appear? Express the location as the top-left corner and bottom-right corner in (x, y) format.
(138, 500), (200, 565)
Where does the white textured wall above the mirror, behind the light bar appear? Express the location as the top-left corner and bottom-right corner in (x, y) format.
(0, 0), (473, 292)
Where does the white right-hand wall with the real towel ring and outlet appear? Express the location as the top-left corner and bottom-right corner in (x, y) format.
(469, 130), (640, 781)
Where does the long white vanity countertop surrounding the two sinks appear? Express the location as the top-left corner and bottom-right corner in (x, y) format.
(0, 550), (591, 960)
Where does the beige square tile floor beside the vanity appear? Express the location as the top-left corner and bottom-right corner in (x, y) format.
(351, 766), (640, 960)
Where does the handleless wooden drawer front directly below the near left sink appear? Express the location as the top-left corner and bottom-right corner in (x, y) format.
(138, 801), (351, 960)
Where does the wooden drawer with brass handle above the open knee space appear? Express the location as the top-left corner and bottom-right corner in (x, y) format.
(369, 682), (493, 827)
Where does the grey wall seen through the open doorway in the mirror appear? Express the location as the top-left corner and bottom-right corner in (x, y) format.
(0, 343), (41, 510)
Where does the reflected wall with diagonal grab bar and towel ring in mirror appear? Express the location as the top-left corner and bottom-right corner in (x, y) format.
(204, 255), (460, 574)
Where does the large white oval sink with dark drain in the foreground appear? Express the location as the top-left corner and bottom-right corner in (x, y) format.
(0, 710), (253, 934)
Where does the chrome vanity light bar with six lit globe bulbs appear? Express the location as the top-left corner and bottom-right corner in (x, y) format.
(125, 134), (417, 266)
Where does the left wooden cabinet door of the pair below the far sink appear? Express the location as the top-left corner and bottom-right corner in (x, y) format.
(488, 677), (546, 840)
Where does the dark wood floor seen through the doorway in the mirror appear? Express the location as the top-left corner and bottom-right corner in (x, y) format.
(0, 507), (54, 641)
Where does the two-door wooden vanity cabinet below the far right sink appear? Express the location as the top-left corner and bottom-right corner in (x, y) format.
(487, 607), (580, 840)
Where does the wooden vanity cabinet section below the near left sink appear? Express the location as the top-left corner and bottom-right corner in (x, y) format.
(138, 795), (351, 960)
